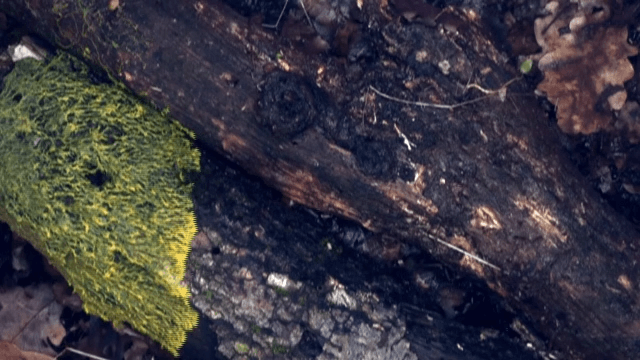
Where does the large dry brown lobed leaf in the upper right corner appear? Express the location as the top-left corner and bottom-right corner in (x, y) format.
(535, 0), (638, 134)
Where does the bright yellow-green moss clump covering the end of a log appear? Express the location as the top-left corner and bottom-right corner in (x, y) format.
(0, 54), (200, 354)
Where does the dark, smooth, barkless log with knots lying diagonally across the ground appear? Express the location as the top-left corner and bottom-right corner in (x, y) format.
(0, 0), (640, 360)
